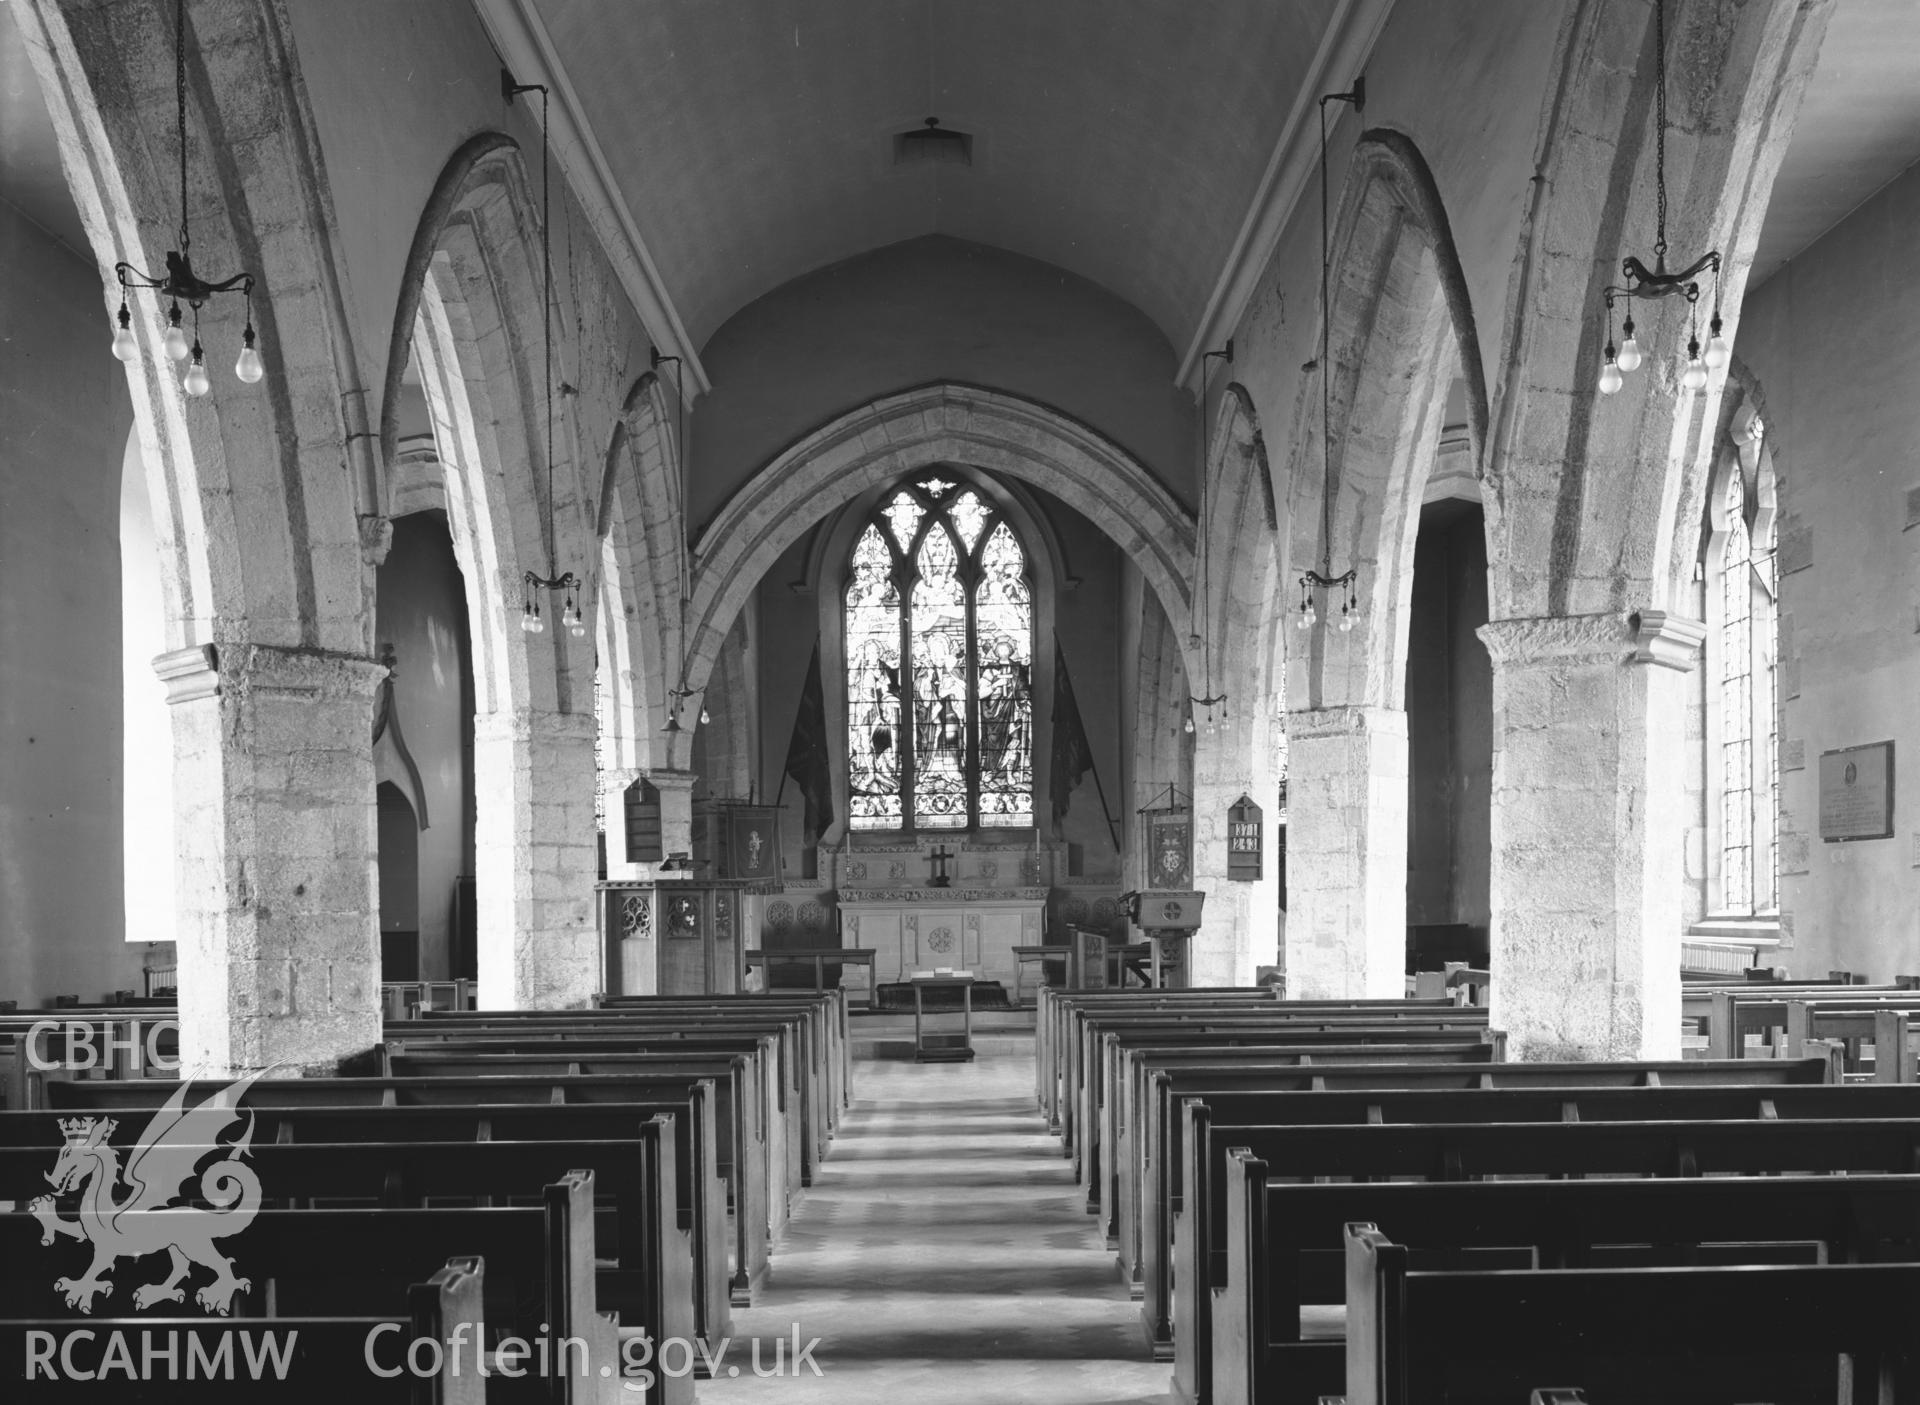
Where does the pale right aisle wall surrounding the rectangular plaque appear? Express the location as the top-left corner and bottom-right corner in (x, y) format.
(1734, 167), (1920, 981)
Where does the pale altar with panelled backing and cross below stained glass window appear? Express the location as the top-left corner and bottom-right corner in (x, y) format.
(839, 841), (1048, 992)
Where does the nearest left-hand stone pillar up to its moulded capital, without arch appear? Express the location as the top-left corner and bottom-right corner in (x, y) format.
(154, 643), (386, 1077)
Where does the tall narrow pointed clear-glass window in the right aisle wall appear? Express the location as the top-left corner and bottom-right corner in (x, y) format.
(1707, 415), (1780, 916)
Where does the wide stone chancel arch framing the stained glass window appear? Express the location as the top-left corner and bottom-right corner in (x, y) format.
(682, 382), (1194, 689)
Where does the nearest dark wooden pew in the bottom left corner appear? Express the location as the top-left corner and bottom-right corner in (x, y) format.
(0, 1257), (487, 1405)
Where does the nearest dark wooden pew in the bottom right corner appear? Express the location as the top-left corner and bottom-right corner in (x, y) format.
(1346, 1225), (1920, 1405)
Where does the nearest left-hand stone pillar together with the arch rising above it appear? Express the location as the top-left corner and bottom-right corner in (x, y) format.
(13, 0), (382, 1075)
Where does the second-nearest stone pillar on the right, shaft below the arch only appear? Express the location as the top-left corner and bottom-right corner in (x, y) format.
(1286, 706), (1407, 1000)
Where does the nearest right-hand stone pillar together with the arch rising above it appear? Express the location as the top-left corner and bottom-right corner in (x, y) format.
(1480, 0), (1834, 1058)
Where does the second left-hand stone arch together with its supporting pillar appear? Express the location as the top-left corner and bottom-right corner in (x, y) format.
(380, 132), (601, 1008)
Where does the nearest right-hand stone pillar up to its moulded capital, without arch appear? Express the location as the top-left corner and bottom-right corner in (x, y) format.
(1480, 610), (1705, 1060)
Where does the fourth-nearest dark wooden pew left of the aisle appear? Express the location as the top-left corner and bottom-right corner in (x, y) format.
(37, 1077), (741, 1340)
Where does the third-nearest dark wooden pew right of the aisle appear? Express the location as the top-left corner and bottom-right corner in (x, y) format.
(1198, 1119), (1920, 1405)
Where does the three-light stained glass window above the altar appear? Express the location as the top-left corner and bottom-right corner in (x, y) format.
(843, 478), (1033, 829)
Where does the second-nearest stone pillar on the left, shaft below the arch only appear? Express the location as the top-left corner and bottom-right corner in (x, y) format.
(474, 708), (603, 1010)
